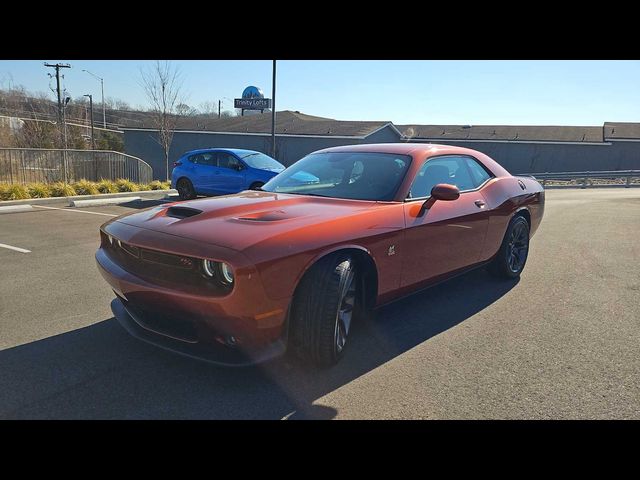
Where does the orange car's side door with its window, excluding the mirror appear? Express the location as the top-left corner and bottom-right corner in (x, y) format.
(402, 155), (489, 286)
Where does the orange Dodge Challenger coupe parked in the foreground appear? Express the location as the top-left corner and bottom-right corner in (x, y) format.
(96, 143), (544, 365)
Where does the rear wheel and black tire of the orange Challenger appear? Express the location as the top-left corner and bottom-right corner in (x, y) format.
(487, 215), (529, 278)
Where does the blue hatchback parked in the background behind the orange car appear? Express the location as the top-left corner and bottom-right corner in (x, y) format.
(171, 148), (285, 200)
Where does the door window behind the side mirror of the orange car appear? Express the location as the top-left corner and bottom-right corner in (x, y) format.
(409, 156), (475, 198)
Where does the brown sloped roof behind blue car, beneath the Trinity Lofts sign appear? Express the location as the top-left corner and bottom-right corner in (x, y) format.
(170, 110), (391, 137)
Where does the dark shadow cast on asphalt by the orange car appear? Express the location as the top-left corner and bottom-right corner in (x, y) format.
(0, 270), (517, 419)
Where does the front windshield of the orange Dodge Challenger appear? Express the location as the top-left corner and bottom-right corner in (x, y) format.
(262, 152), (411, 201)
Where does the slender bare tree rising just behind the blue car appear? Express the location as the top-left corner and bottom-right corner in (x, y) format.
(140, 61), (184, 180)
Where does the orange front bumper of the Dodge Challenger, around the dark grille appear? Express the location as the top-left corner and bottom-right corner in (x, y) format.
(96, 223), (290, 365)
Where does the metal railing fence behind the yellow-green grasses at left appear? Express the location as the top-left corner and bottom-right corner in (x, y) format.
(0, 148), (153, 183)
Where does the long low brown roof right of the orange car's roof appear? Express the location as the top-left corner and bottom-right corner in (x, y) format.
(397, 125), (602, 142)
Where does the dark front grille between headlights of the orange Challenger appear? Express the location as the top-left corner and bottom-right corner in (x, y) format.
(100, 232), (230, 296)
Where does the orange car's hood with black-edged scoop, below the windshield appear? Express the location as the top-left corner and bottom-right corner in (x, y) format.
(115, 191), (379, 251)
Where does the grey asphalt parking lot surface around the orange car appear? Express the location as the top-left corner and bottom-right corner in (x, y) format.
(0, 189), (640, 419)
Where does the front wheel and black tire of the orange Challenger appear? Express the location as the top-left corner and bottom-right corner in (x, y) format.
(289, 254), (360, 366)
